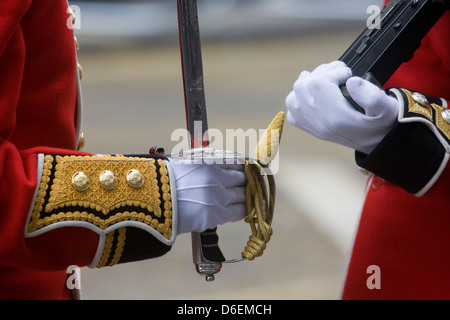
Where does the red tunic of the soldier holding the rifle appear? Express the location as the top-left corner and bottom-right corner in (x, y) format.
(342, 12), (450, 299)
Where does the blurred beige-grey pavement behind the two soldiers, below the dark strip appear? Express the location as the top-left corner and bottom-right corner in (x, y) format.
(79, 28), (366, 299)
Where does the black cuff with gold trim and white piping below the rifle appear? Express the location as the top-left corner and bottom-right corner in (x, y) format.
(355, 88), (450, 197)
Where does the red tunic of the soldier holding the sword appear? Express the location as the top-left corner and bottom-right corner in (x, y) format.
(0, 0), (175, 299)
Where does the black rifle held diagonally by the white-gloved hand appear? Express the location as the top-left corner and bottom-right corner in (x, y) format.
(339, 0), (450, 113)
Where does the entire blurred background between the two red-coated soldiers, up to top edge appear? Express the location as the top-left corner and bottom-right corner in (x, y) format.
(74, 0), (382, 299)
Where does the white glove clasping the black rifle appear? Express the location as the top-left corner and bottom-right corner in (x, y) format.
(286, 61), (398, 154)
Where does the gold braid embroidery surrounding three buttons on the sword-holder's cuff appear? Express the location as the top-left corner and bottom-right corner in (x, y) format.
(27, 155), (172, 239)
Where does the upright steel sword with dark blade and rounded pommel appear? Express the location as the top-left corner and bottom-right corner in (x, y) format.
(177, 0), (225, 281)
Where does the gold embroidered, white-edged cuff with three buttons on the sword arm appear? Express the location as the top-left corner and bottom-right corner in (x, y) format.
(26, 155), (176, 265)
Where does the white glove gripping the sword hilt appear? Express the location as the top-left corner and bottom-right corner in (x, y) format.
(170, 160), (247, 234)
